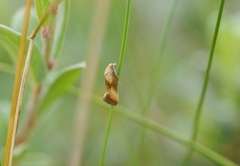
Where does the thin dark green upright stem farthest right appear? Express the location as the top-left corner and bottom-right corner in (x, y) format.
(183, 0), (225, 165)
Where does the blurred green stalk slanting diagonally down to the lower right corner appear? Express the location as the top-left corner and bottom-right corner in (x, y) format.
(69, 87), (237, 166)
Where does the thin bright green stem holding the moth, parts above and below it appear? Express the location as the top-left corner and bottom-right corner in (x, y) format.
(100, 0), (131, 166)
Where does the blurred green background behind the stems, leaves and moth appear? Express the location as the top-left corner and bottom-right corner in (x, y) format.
(0, 0), (240, 166)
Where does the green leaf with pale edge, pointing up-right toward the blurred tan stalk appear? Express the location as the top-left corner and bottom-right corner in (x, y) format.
(38, 62), (85, 113)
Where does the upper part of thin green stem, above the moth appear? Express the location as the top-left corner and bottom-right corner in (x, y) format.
(117, 0), (131, 77)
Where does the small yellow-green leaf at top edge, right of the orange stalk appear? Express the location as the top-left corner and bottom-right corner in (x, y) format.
(35, 0), (50, 27)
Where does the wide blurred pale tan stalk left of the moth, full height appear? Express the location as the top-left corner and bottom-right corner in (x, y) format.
(68, 0), (111, 166)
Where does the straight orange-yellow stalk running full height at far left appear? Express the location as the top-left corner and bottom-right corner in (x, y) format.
(4, 0), (32, 166)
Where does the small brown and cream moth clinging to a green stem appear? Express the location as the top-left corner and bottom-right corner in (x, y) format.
(103, 63), (118, 106)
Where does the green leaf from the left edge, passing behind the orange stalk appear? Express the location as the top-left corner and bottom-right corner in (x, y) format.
(0, 25), (47, 83)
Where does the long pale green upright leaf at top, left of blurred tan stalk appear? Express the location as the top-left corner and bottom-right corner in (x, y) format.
(51, 0), (70, 58)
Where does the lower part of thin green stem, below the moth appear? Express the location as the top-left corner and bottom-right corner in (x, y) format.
(100, 106), (114, 166)
